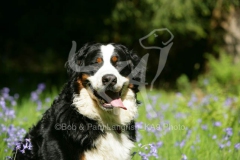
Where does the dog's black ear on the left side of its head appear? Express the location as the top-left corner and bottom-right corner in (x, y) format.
(65, 41), (90, 76)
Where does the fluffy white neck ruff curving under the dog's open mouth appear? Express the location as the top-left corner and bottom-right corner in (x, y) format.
(73, 88), (137, 127)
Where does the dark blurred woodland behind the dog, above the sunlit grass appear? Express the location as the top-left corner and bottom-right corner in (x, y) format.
(0, 0), (240, 93)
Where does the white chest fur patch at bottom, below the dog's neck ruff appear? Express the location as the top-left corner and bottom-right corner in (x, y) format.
(84, 131), (134, 160)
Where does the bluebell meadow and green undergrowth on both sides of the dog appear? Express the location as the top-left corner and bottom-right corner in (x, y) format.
(0, 53), (240, 160)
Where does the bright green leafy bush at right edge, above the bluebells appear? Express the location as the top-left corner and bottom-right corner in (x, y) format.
(199, 53), (240, 93)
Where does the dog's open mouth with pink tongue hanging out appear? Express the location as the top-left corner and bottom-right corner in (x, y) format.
(90, 87), (127, 110)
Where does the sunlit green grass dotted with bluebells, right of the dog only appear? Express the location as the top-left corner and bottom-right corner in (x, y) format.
(135, 91), (240, 160)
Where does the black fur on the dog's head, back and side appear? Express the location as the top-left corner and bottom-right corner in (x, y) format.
(12, 43), (141, 160)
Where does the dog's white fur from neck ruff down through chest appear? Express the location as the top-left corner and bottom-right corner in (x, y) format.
(73, 89), (137, 160)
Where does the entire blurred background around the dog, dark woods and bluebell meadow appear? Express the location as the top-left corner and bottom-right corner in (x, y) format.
(0, 0), (240, 160)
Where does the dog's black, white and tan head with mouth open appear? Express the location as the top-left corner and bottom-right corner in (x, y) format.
(67, 43), (139, 110)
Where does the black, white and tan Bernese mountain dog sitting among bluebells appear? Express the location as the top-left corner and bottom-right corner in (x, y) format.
(12, 43), (139, 160)
